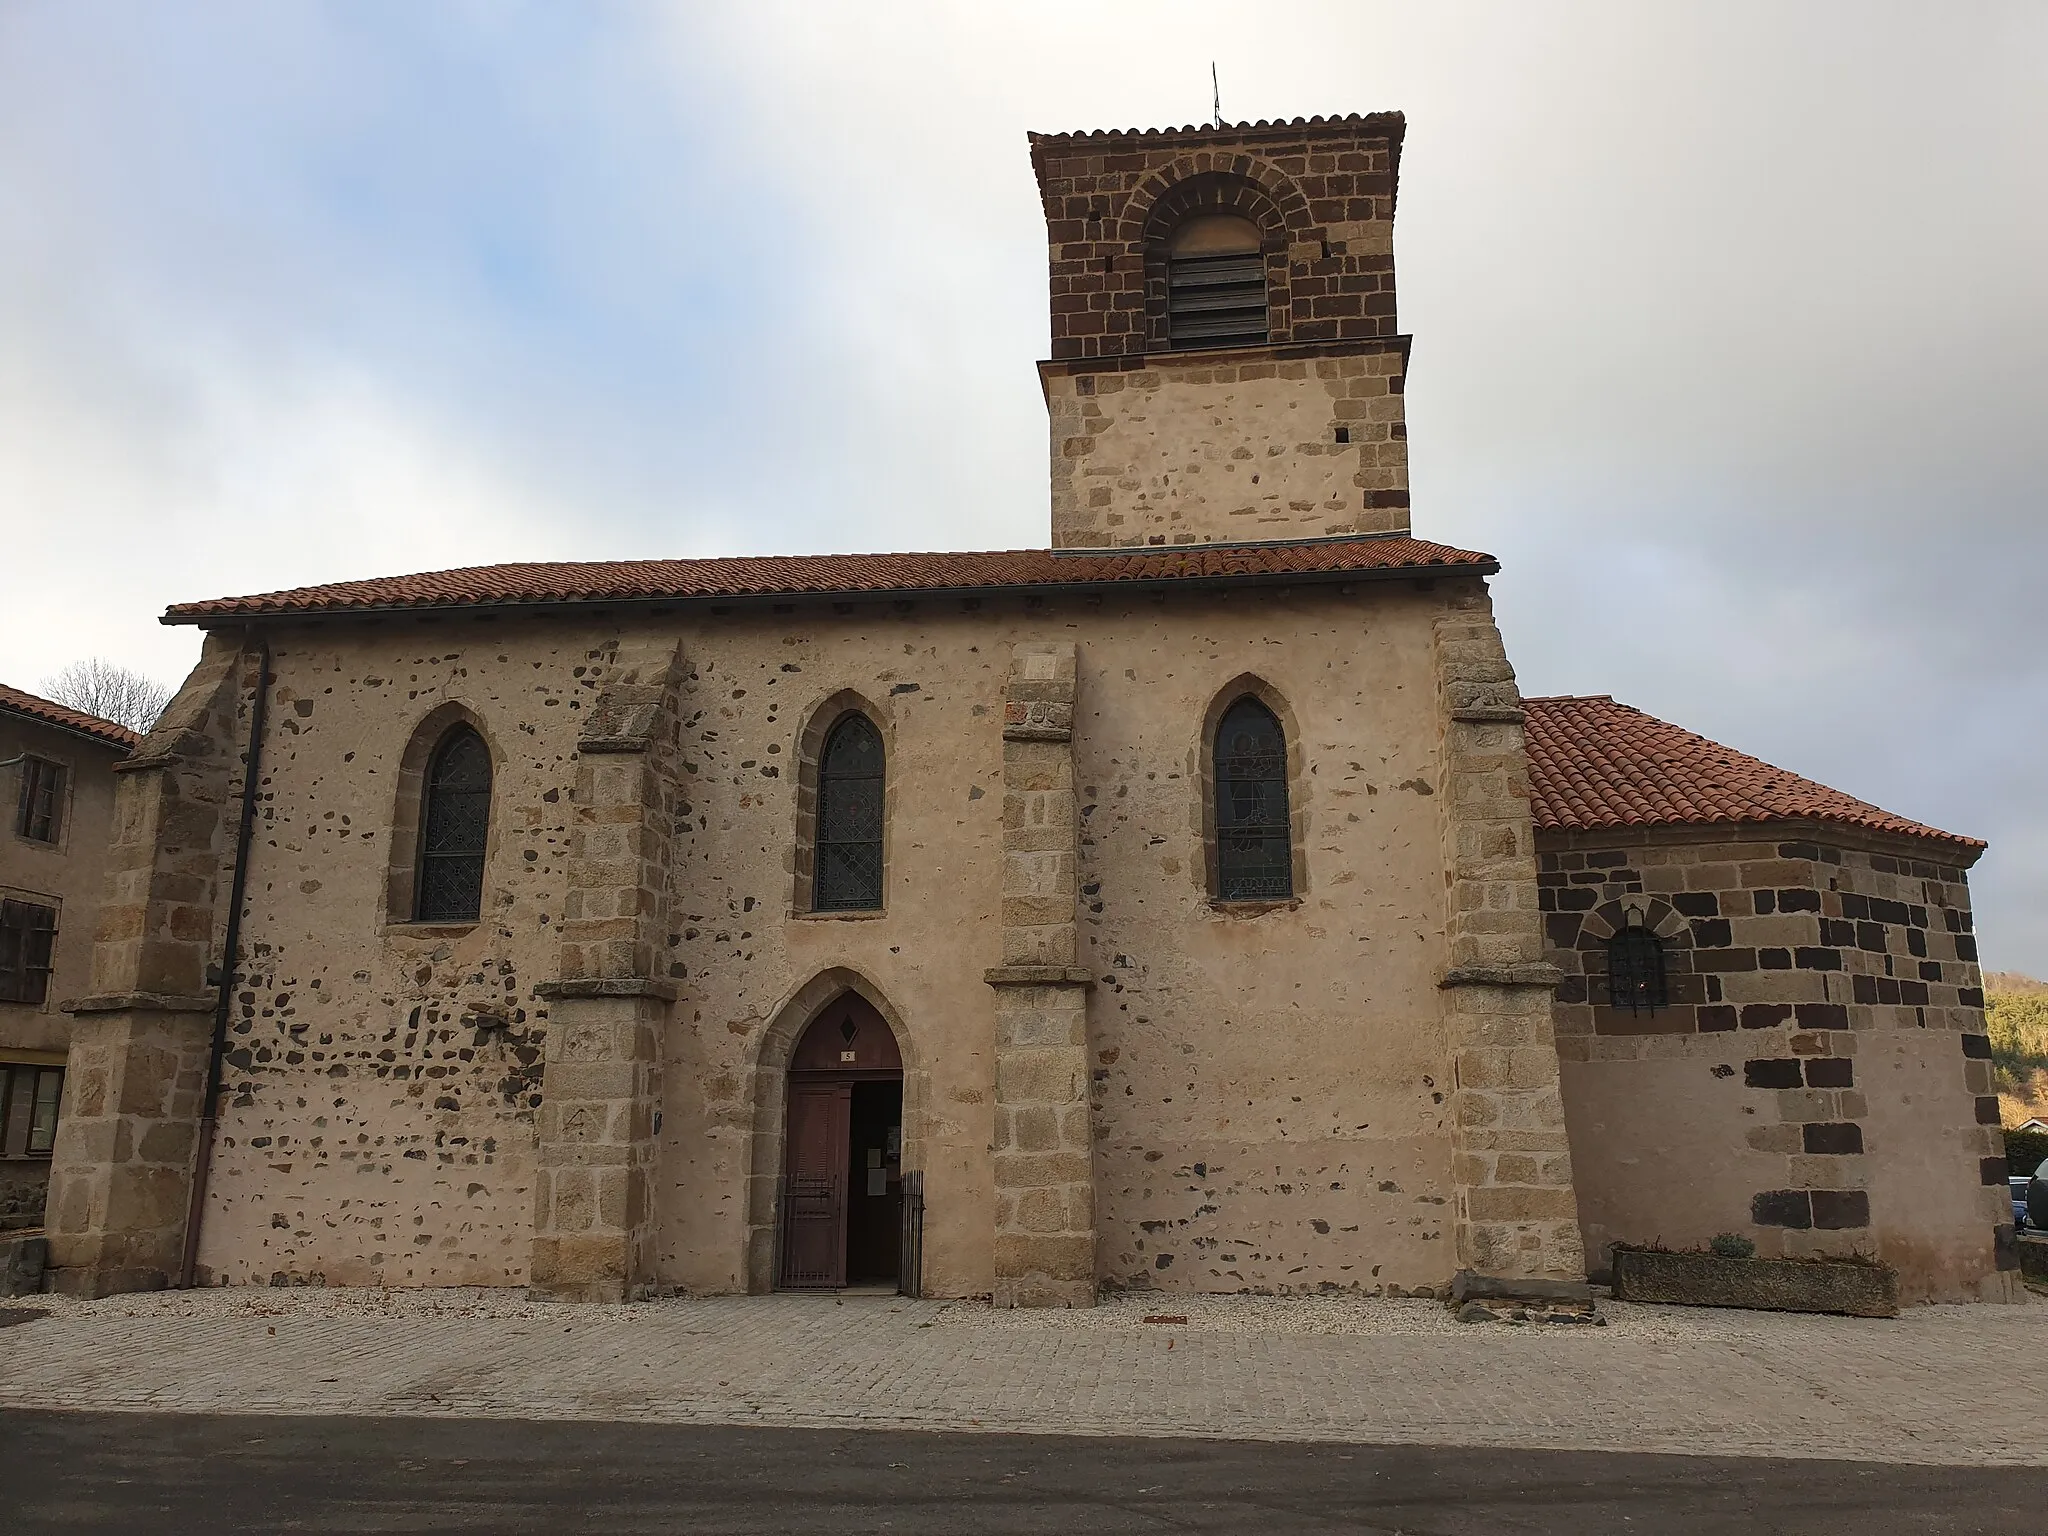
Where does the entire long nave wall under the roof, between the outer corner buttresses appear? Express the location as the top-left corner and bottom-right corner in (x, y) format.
(116, 580), (1507, 1300)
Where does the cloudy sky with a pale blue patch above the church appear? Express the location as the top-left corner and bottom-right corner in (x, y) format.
(0, 0), (2048, 975)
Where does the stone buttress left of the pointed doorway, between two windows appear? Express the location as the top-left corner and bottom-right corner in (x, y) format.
(528, 639), (680, 1303)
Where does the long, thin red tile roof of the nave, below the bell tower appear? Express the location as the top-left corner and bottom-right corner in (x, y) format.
(164, 537), (1499, 625)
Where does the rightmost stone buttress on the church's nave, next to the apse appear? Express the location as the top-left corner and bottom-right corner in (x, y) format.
(1436, 584), (1585, 1298)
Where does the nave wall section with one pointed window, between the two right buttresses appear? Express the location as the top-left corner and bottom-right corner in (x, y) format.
(1075, 582), (1507, 1292)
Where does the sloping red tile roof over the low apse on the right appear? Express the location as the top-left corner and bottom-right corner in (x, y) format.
(1522, 694), (1985, 856)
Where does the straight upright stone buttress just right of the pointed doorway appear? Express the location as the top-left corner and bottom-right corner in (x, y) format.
(987, 641), (1096, 1307)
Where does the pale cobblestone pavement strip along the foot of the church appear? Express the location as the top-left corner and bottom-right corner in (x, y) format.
(0, 1290), (2048, 1466)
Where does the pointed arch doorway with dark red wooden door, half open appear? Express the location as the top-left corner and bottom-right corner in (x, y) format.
(776, 991), (905, 1290)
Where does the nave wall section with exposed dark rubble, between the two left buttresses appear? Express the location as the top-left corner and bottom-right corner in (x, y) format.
(184, 625), (593, 1286)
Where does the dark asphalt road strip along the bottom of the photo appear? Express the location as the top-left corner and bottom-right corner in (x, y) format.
(0, 1411), (2048, 1536)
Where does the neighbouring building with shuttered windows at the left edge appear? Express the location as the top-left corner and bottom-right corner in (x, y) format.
(0, 686), (139, 1227)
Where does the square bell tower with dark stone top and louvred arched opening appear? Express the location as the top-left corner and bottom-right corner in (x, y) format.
(1030, 113), (1409, 549)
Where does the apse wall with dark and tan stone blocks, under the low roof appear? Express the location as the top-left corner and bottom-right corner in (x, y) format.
(1540, 825), (2011, 1300)
